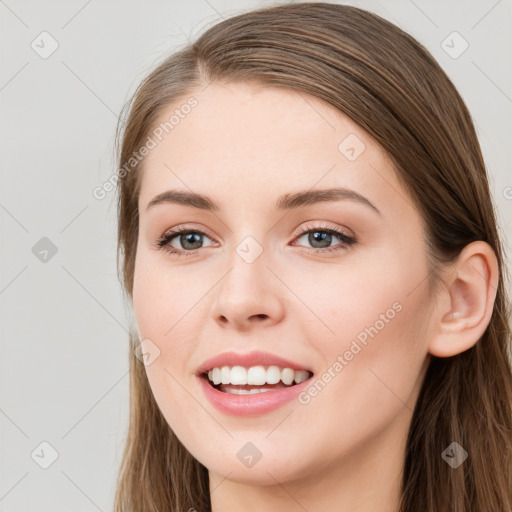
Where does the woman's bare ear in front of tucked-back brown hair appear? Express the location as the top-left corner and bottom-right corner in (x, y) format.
(428, 241), (499, 357)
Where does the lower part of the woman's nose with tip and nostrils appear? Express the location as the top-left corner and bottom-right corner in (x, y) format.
(212, 249), (285, 332)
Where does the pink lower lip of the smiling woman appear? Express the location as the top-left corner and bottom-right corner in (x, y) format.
(197, 376), (311, 416)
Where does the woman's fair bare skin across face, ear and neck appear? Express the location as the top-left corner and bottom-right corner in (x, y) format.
(133, 83), (497, 512)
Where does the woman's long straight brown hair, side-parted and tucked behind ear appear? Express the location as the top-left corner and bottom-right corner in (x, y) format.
(115, 2), (512, 512)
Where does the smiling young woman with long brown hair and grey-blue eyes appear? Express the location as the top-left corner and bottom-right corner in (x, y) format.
(115, 3), (512, 512)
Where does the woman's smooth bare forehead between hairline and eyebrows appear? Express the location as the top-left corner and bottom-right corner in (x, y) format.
(139, 83), (406, 216)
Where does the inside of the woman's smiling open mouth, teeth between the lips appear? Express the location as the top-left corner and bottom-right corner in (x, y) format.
(200, 366), (313, 395)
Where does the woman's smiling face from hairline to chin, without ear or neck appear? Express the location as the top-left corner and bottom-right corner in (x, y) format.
(133, 83), (430, 485)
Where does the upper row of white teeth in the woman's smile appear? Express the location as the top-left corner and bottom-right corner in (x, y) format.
(208, 366), (309, 386)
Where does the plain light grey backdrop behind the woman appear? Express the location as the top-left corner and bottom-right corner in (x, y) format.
(0, 0), (512, 512)
